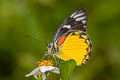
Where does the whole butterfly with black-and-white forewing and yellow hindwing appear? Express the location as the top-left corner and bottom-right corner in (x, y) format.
(47, 8), (92, 65)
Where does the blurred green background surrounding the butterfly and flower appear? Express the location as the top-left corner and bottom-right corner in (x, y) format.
(0, 0), (120, 80)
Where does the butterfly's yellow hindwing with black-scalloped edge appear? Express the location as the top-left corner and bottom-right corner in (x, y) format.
(56, 31), (91, 65)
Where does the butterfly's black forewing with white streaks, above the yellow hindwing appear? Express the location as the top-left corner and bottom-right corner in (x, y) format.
(53, 8), (87, 42)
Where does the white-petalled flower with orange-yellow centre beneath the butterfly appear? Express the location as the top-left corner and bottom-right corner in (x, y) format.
(25, 60), (60, 80)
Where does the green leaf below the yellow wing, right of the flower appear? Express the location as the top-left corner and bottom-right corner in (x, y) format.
(59, 60), (76, 80)
